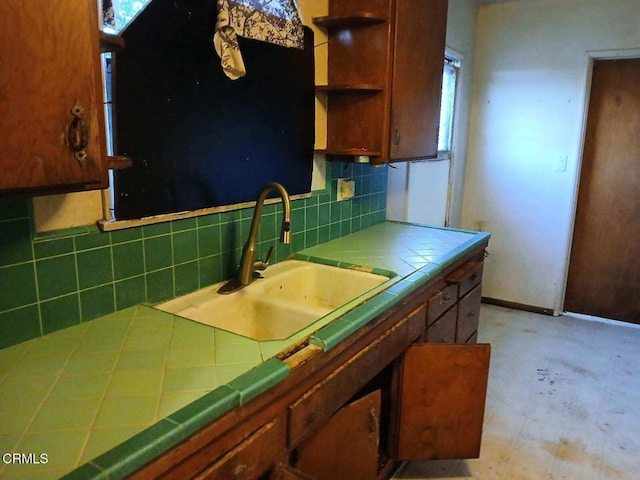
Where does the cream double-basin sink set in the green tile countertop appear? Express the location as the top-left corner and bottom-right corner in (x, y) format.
(155, 260), (389, 341)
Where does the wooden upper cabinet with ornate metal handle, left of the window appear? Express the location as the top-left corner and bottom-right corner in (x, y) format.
(0, 0), (107, 194)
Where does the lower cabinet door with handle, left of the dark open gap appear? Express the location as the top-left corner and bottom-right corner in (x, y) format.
(296, 390), (381, 480)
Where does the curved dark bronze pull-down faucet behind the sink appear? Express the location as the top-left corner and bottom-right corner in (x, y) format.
(218, 182), (291, 294)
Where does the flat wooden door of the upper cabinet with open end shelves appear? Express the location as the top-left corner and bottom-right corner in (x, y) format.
(390, 0), (447, 160)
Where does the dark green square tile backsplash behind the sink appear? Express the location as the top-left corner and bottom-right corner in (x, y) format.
(0, 162), (387, 348)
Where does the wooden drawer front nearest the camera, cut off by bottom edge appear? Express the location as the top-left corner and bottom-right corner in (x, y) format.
(195, 417), (286, 480)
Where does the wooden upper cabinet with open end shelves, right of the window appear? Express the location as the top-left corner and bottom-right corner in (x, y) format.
(314, 0), (447, 164)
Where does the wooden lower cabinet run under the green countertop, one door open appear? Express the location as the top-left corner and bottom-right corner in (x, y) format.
(131, 246), (491, 480)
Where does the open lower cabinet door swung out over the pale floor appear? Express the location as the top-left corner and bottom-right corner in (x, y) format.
(396, 344), (491, 460)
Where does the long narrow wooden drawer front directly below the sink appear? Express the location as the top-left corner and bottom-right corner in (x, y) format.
(288, 305), (425, 447)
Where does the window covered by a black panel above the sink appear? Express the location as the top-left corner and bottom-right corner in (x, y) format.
(98, 0), (315, 221)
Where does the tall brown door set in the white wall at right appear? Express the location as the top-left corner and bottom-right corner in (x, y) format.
(564, 59), (640, 323)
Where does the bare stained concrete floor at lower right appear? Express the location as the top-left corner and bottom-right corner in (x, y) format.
(393, 305), (640, 480)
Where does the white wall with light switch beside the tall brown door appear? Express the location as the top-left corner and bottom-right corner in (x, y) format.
(462, 0), (640, 313)
